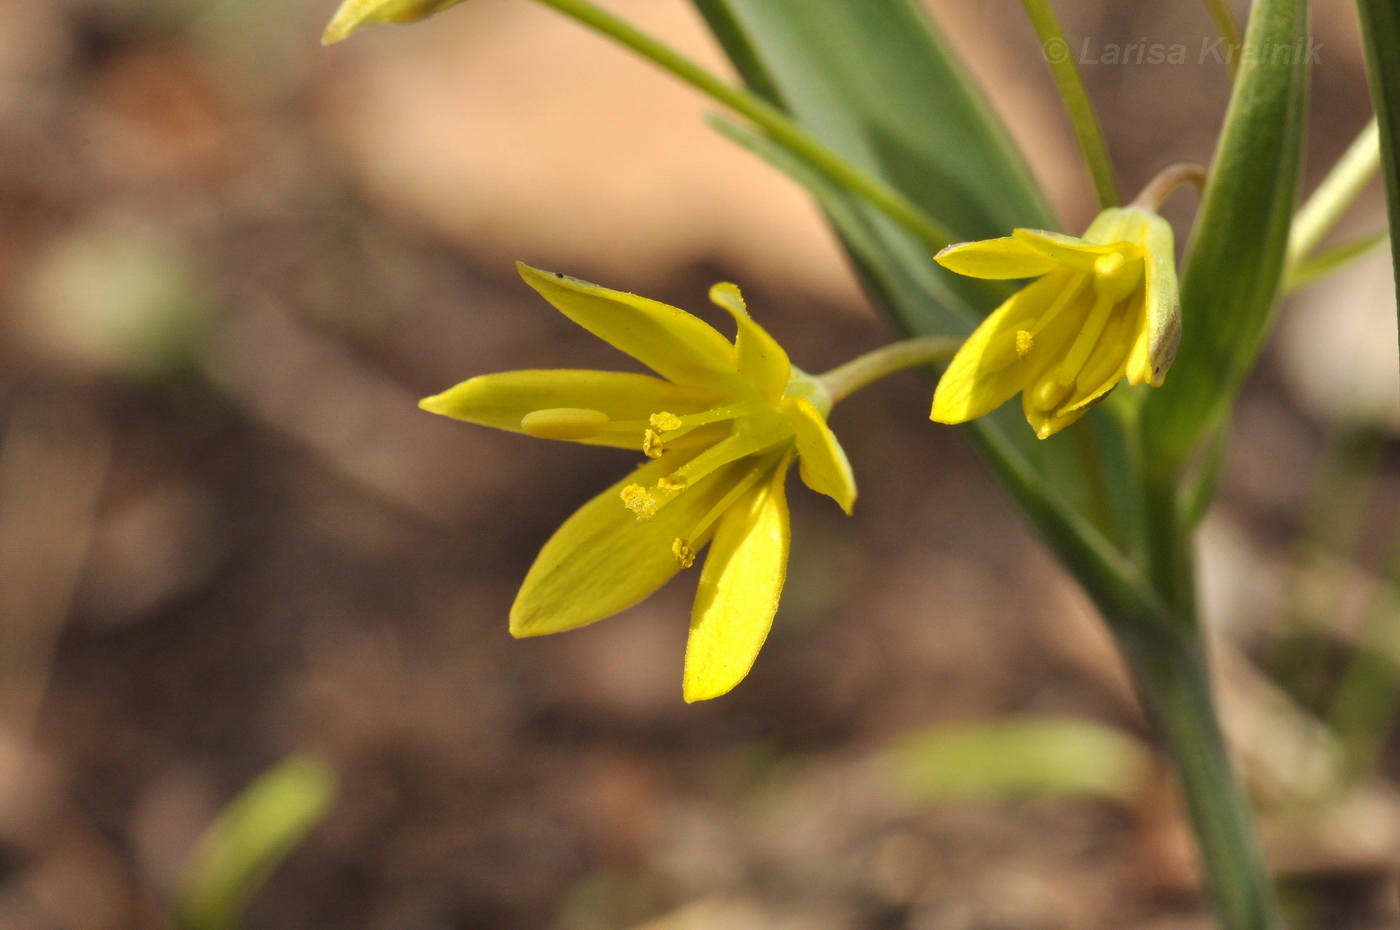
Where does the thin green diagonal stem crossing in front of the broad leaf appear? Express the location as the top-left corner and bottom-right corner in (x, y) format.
(539, 0), (955, 251)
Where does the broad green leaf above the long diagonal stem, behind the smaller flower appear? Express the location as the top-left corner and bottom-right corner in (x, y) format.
(696, 0), (1058, 254)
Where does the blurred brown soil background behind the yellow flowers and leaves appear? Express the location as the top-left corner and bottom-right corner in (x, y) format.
(0, 0), (1400, 930)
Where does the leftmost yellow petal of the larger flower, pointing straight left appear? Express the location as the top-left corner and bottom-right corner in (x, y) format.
(419, 368), (718, 450)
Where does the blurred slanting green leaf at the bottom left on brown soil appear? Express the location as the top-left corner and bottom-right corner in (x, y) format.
(176, 755), (336, 930)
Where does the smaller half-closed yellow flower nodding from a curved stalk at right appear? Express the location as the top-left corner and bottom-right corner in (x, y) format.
(931, 207), (1182, 438)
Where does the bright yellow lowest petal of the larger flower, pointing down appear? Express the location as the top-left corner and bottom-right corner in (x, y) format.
(683, 466), (791, 702)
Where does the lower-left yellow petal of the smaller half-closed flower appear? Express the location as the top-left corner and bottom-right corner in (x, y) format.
(930, 269), (1082, 423)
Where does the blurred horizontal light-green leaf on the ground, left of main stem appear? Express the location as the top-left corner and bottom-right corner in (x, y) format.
(886, 717), (1152, 803)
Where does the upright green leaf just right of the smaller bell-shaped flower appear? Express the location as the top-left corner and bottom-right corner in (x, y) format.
(1142, 0), (1312, 471)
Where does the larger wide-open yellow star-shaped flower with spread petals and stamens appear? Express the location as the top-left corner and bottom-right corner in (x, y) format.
(420, 265), (855, 700)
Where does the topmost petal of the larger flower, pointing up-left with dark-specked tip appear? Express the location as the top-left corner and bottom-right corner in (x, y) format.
(515, 262), (741, 387)
